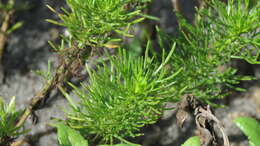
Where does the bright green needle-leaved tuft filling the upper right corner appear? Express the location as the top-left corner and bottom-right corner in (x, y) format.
(203, 0), (260, 64)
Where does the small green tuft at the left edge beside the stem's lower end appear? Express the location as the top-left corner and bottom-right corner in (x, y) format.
(0, 97), (26, 144)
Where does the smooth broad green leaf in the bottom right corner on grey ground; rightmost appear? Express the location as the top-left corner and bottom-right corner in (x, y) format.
(234, 117), (260, 146)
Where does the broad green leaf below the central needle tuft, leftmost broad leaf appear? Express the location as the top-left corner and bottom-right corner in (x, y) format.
(55, 123), (88, 146)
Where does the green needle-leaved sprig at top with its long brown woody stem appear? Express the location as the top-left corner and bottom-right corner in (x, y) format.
(14, 0), (152, 135)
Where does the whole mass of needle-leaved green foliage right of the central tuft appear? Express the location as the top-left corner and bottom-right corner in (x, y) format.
(166, 0), (260, 103)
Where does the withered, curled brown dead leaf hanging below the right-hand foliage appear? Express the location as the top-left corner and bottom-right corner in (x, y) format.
(176, 95), (230, 146)
